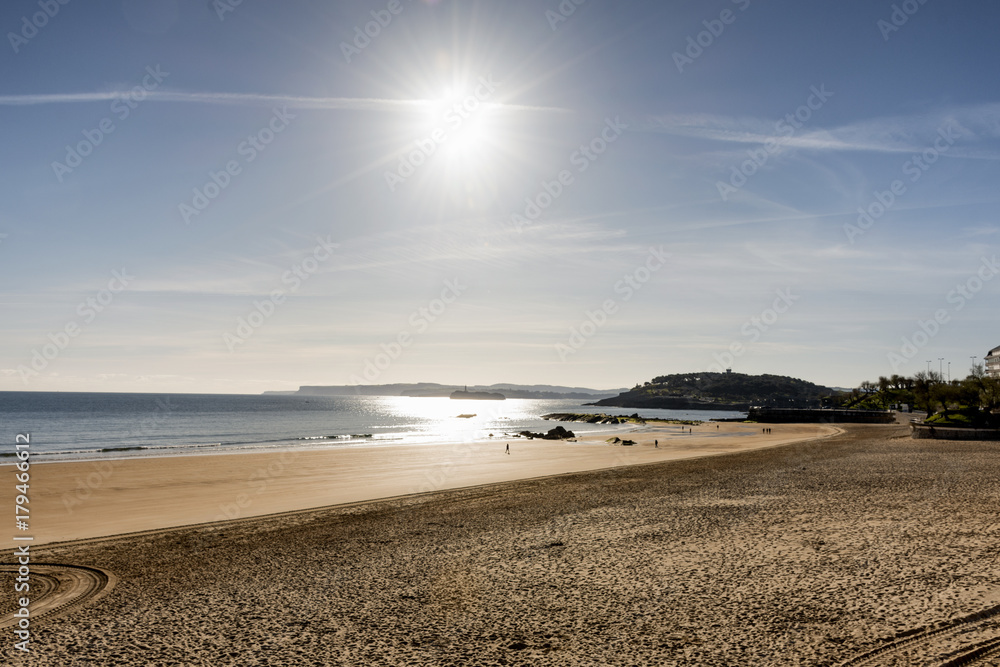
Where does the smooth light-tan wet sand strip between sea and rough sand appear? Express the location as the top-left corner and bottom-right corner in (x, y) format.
(0, 424), (839, 546)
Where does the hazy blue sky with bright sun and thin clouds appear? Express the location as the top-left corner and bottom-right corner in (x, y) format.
(0, 0), (1000, 393)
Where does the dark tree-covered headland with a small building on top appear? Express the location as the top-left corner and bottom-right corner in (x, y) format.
(590, 373), (836, 411)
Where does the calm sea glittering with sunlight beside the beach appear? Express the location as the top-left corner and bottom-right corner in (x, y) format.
(0, 392), (745, 463)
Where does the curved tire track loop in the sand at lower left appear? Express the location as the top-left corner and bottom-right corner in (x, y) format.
(0, 563), (118, 629)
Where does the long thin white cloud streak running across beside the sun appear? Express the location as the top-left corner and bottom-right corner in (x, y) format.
(0, 90), (570, 113)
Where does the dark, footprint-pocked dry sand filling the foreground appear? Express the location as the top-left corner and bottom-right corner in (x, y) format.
(4, 426), (1000, 667)
